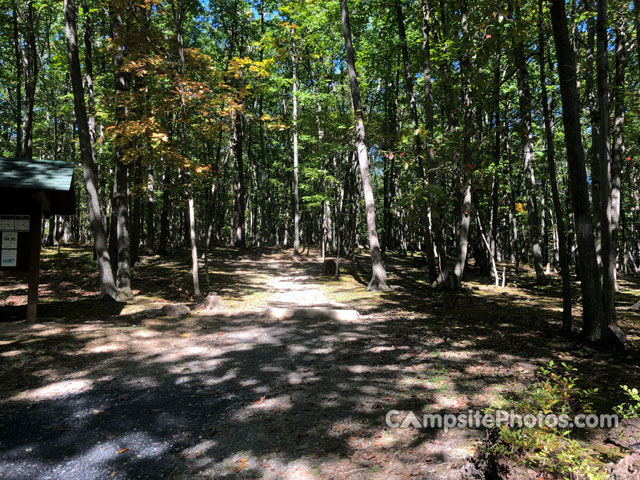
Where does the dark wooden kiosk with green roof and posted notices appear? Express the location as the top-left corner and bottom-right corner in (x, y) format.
(0, 157), (76, 322)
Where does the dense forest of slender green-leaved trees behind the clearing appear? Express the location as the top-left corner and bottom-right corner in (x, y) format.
(0, 0), (640, 478)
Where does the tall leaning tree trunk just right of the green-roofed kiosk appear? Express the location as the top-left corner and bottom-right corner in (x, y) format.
(64, 0), (118, 300)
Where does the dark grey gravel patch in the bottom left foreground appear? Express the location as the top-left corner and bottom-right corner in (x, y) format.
(0, 382), (234, 480)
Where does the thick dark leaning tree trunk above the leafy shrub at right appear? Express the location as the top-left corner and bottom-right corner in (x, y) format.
(551, 0), (624, 344)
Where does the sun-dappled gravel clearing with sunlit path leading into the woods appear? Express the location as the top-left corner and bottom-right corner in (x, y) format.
(0, 256), (496, 480)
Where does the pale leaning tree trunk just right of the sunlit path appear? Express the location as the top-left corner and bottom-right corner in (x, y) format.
(340, 0), (389, 291)
